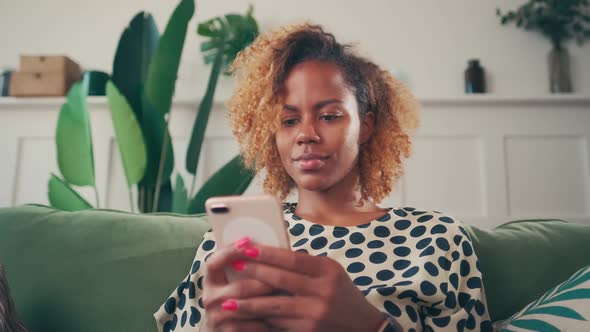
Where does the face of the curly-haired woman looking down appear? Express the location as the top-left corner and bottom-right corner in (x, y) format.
(276, 61), (373, 191)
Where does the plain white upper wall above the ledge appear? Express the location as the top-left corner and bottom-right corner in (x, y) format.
(0, 0), (590, 99)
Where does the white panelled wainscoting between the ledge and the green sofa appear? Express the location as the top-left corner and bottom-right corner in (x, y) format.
(0, 95), (590, 227)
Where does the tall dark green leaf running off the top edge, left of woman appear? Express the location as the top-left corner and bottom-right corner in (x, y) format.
(145, 0), (195, 113)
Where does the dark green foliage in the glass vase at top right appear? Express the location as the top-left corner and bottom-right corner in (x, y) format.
(496, 0), (590, 49)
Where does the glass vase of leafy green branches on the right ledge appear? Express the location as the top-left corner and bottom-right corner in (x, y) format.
(496, 0), (590, 93)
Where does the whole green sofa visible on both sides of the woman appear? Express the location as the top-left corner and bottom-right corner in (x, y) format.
(0, 205), (590, 332)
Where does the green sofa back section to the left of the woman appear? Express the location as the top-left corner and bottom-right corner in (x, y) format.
(0, 206), (209, 331)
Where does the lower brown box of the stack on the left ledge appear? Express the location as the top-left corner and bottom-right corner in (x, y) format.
(10, 71), (73, 97)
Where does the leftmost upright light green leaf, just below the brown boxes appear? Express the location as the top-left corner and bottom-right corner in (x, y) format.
(55, 82), (95, 186)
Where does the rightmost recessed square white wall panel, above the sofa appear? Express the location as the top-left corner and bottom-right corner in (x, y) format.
(505, 136), (589, 217)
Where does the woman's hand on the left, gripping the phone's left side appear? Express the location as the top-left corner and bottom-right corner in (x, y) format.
(202, 238), (273, 332)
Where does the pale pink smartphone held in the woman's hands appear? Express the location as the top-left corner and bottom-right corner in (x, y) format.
(205, 195), (291, 281)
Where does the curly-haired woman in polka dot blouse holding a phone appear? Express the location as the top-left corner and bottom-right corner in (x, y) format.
(155, 24), (491, 331)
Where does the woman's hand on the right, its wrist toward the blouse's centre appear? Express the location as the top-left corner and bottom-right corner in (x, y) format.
(219, 241), (384, 331)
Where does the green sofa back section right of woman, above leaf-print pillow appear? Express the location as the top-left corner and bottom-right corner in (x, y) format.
(467, 219), (590, 321)
